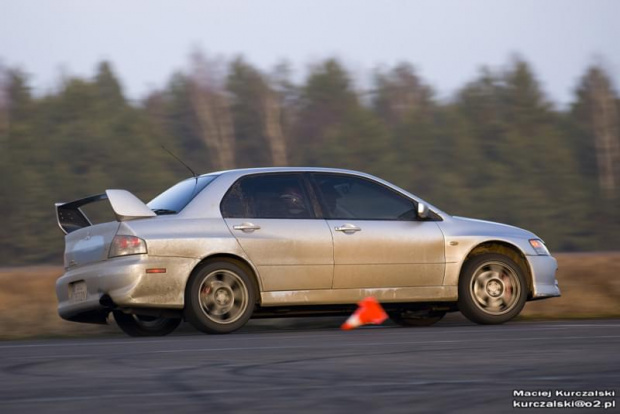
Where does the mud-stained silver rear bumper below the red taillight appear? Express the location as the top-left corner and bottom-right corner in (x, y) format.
(56, 255), (198, 323)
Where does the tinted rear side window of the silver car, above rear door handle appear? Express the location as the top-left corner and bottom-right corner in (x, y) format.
(220, 174), (314, 219)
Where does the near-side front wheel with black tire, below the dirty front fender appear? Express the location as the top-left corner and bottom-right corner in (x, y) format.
(458, 253), (528, 325)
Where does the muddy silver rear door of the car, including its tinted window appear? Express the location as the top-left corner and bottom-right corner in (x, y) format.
(220, 173), (334, 291)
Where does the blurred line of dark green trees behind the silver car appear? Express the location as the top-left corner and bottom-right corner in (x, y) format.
(0, 53), (620, 265)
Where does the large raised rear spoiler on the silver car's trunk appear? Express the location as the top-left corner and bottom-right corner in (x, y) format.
(56, 190), (156, 234)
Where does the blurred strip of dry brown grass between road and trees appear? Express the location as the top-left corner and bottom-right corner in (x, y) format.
(0, 252), (620, 339)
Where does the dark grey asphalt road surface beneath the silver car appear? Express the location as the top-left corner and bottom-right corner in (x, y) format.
(0, 320), (620, 414)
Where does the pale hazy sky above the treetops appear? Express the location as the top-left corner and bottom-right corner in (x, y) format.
(0, 0), (620, 105)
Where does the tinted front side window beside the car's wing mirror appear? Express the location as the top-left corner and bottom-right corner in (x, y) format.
(313, 173), (416, 220)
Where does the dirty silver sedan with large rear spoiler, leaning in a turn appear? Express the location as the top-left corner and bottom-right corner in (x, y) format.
(56, 168), (560, 336)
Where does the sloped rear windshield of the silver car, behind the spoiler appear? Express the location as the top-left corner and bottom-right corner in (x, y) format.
(147, 175), (217, 214)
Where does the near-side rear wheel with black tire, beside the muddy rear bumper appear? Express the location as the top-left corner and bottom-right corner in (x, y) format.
(185, 261), (257, 334)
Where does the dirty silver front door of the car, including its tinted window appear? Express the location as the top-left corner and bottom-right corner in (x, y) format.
(311, 173), (445, 289)
